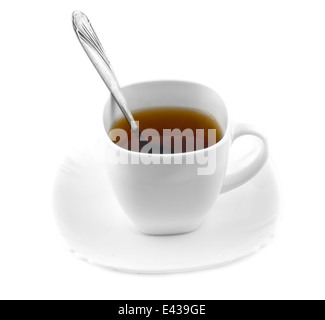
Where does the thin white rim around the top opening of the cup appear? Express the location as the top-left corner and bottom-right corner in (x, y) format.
(103, 80), (231, 158)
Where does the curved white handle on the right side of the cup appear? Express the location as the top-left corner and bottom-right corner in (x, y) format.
(220, 124), (268, 194)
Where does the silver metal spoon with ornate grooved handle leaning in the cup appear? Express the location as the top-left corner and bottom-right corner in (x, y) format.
(72, 11), (139, 132)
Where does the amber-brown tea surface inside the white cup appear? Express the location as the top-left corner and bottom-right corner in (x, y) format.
(110, 107), (223, 153)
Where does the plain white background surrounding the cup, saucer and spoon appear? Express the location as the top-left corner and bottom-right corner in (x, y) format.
(0, 0), (325, 299)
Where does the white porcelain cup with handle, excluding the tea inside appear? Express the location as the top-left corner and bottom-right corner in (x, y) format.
(104, 81), (268, 235)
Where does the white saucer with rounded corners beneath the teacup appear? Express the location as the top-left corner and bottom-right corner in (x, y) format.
(54, 140), (279, 273)
